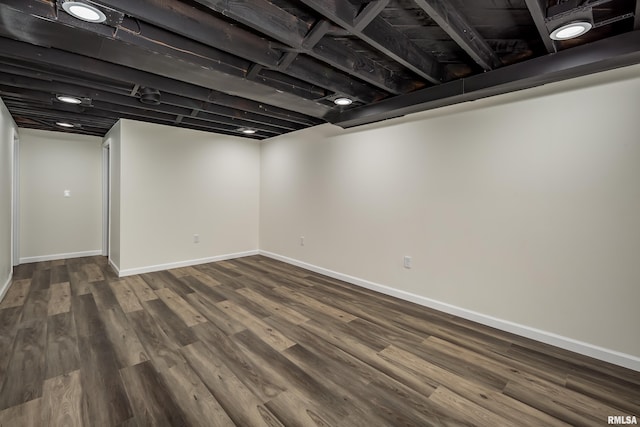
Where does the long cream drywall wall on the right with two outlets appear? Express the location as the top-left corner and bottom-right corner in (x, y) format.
(260, 66), (640, 362)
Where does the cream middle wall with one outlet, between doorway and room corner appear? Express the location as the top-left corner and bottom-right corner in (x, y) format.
(114, 120), (260, 274)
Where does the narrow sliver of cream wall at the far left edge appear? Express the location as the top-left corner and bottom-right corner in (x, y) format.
(0, 99), (17, 300)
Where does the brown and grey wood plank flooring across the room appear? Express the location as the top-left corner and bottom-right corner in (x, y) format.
(0, 256), (640, 427)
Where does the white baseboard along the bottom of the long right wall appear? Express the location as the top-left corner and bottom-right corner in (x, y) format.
(260, 250), (640, 372)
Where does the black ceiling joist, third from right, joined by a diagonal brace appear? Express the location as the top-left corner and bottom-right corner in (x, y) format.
(301, 0), (444, 83)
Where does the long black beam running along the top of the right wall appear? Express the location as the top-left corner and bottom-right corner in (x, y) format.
(329, 31), (640, 128)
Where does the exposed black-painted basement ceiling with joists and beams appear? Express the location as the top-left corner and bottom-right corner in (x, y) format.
(0, 0), (640, 139)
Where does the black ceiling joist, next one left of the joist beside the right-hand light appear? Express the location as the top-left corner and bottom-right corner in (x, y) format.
(415, 0), (502, 71)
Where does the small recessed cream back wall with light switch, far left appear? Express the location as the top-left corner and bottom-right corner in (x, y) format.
(19, 129), (102, 263)
